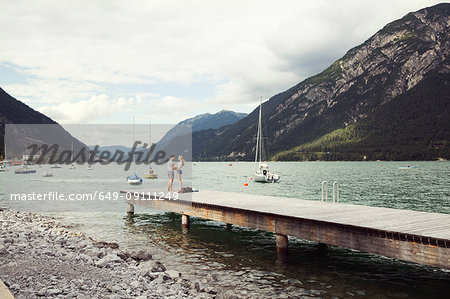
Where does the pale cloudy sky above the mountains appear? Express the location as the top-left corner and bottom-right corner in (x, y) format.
(0, 0), (439, 124)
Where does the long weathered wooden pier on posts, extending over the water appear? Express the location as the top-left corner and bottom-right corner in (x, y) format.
(121, 190), (450, 269)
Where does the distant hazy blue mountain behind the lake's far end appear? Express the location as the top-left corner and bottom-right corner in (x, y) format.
(158, 110), (247, 147)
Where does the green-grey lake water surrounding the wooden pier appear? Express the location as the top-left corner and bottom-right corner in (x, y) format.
(0, 162), (450, 298)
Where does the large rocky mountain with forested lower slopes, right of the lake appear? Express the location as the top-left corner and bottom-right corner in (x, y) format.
(192, 3), (450, 160)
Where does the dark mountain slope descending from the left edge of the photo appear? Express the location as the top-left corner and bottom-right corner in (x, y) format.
(0, 88), (87, 159)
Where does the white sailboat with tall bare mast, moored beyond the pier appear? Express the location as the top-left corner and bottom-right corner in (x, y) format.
(253, 101), (280, 183)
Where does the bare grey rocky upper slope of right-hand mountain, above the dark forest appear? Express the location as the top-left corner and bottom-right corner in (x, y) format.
(193, 3), (450, 160)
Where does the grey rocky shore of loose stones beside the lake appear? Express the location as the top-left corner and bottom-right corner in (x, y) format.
(0, 208), (221, 299)
